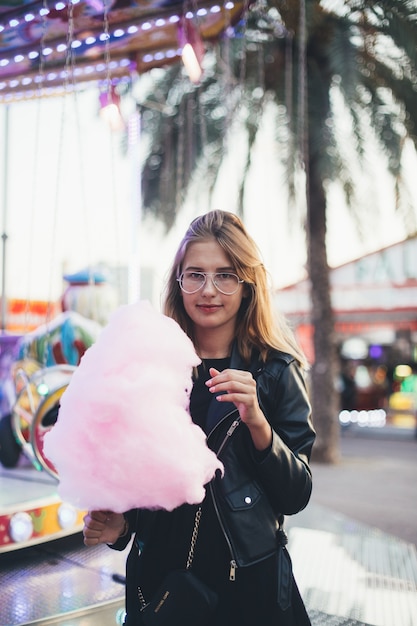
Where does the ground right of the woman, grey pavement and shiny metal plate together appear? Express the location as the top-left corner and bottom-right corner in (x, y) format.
(287, 427), (417, 626)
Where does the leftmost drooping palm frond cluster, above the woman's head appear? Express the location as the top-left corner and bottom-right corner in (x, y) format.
(142, 58), (232, 230)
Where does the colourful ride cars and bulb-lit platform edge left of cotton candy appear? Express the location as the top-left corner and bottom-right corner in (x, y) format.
(0, 272), (117, 552)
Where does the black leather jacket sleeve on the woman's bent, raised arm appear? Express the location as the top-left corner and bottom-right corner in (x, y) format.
(257, 360), (315, 515)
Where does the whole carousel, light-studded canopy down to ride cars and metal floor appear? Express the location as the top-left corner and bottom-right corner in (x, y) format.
(0, 0), (250, 626)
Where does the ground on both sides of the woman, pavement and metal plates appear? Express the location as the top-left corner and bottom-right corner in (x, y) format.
(0, 427), (417, 626)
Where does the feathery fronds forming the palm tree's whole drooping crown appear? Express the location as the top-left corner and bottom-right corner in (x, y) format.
(139, 0), (417, 236)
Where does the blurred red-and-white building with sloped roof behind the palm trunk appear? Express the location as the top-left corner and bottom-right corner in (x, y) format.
(276, 236), (417, 424)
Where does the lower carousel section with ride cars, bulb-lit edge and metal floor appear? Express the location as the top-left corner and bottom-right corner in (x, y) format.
(0, 277), (130, 626)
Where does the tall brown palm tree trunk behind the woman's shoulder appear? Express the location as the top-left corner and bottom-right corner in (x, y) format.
(307, 158), (340, 463)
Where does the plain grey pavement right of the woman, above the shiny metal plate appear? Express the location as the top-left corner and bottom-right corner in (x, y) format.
(311, 427), (417, 544)
